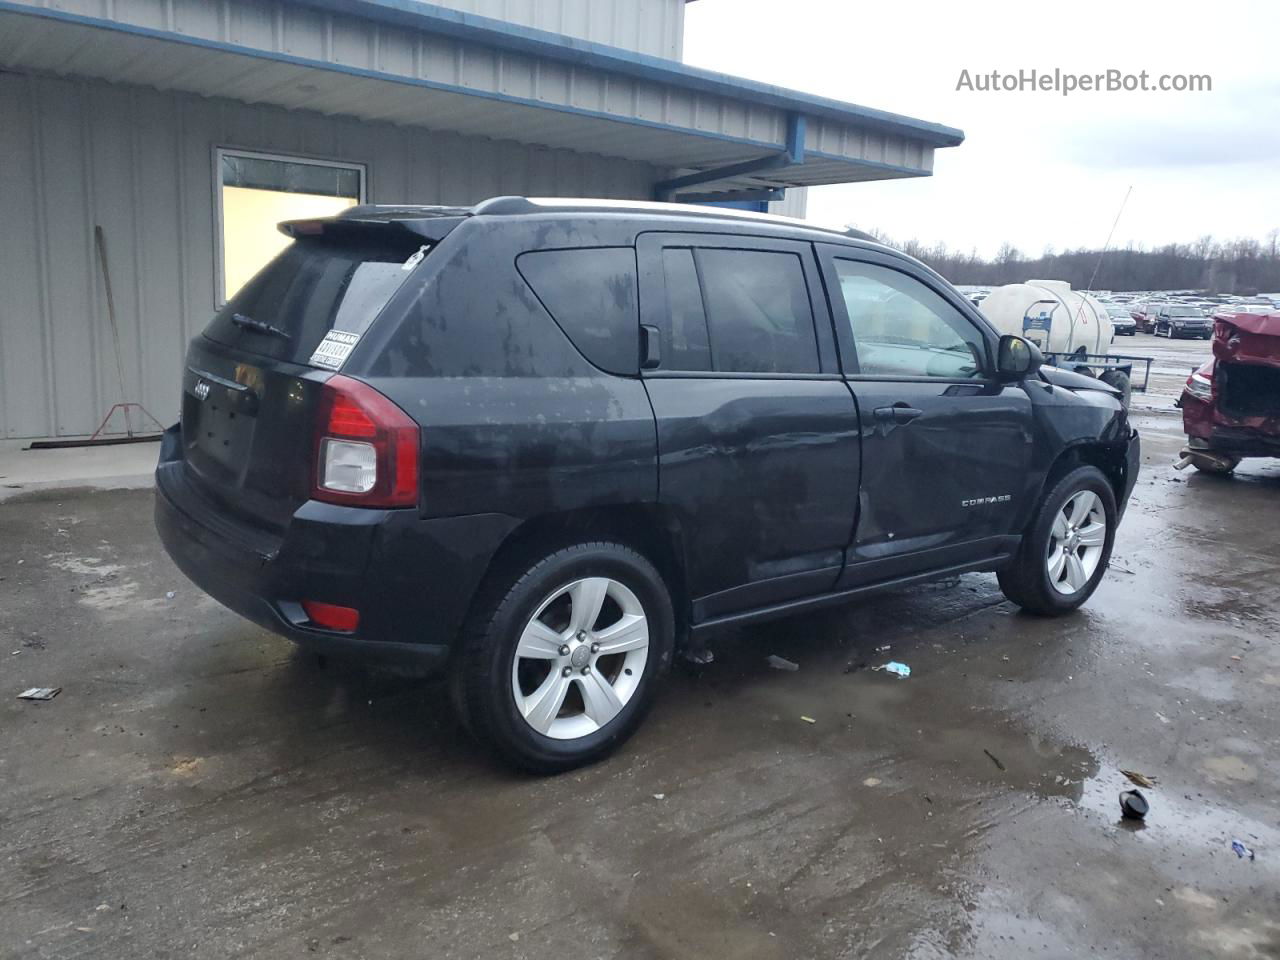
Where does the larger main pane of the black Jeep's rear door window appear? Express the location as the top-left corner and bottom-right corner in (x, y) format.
(695, 248), (819, 374)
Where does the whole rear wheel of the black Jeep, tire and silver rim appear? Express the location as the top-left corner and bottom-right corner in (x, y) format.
(453, 543), (675, 773)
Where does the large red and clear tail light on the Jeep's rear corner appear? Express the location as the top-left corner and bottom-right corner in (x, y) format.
(311, 374), (419, 507)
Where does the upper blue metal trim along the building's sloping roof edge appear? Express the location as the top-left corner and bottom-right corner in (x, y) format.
(307, 0), (964, 147)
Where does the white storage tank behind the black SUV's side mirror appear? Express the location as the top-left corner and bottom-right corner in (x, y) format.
(979, 280), (1112, 355)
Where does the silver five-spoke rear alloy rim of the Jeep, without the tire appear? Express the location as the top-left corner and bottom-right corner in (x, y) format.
(511, 577), (649, 740)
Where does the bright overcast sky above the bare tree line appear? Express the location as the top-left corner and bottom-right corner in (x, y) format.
(685, 0), (1280, 255)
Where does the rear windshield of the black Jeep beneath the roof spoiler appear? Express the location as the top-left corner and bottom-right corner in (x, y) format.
(205, 232), (425, 364)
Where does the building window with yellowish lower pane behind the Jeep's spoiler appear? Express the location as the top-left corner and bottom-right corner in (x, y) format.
(215, 150), (365, 303)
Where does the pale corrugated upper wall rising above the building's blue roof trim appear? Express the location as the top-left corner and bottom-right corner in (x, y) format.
(431, 0), (685, 60)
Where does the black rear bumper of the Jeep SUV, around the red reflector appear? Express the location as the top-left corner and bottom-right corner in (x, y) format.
(155, 432), (515, 675)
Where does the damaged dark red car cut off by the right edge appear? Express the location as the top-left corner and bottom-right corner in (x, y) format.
(1178, 311), (1280, 474)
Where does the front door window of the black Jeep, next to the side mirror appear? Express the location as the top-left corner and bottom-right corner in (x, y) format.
(836, 260), (986, 380)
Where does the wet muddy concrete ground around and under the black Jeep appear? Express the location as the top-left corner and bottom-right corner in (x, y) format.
(0, 338), (1280, 959)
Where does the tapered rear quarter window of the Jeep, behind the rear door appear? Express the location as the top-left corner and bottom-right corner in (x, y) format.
(516, 247), (640, 374)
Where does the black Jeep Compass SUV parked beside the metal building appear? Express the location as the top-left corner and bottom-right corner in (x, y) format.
(156, 197), (1138, 772)
